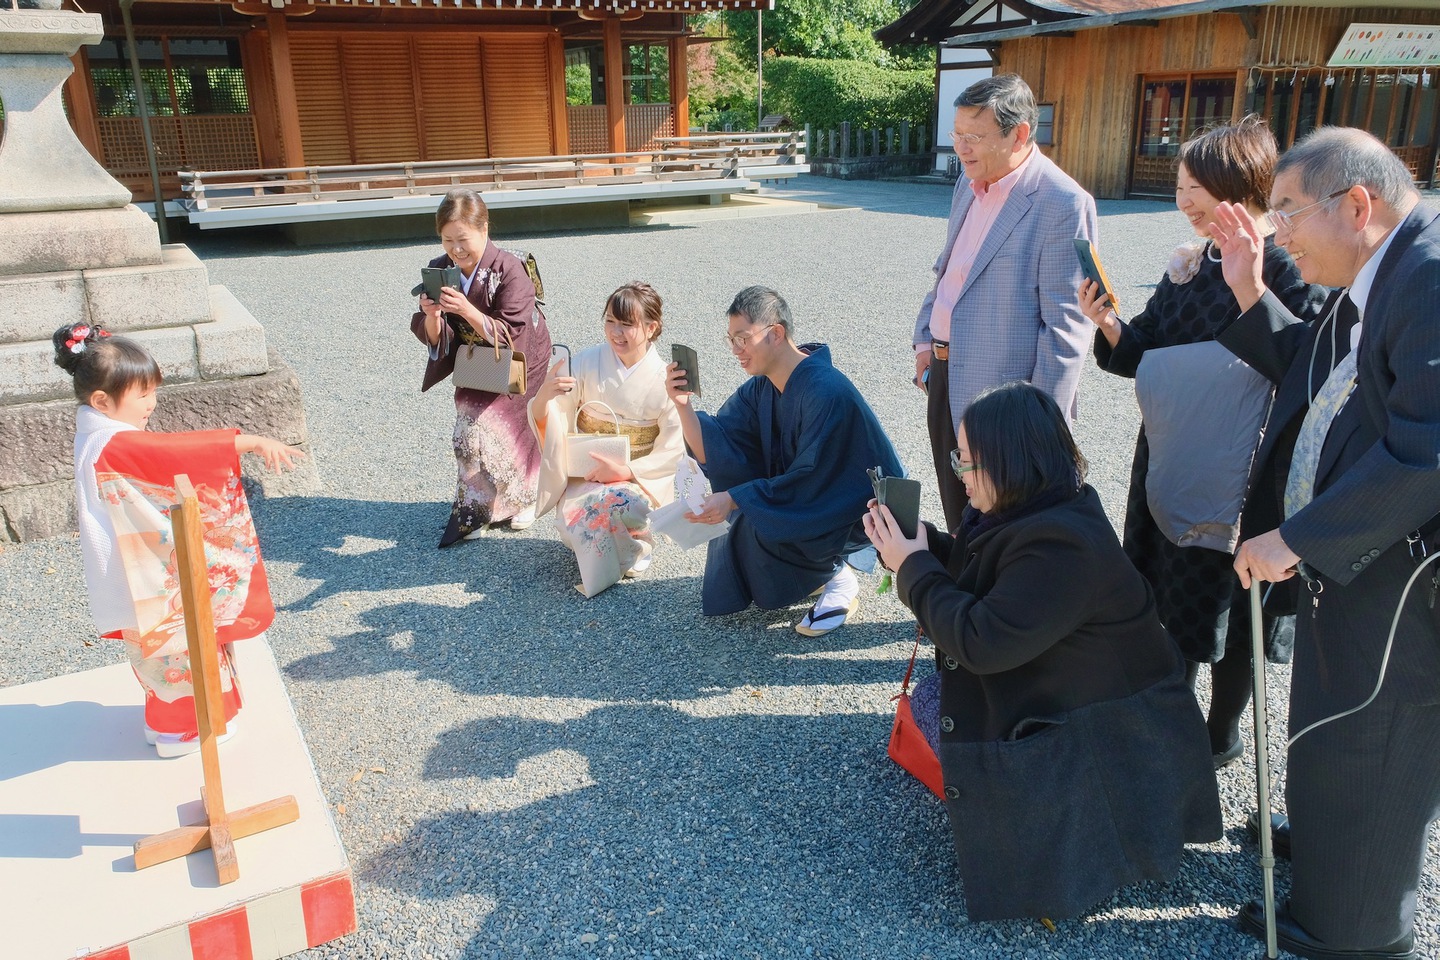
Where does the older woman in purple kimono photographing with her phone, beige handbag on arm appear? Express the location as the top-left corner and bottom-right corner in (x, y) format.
(410, 190), (550, 547)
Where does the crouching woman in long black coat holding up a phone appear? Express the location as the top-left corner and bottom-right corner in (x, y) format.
(865, 383), (1221, 920)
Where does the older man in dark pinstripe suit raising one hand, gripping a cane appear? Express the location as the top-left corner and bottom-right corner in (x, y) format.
(1212, 128), (1440, 960)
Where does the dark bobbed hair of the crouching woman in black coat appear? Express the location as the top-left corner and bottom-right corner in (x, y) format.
(960, 380), (1089, 512)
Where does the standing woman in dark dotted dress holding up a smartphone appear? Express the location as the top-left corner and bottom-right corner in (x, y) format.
(1080, 117), (1325, 769)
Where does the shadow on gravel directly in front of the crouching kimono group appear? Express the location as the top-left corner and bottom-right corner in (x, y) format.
(261, 497), (913, 699)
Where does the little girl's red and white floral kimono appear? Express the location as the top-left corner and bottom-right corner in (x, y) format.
(75, 406), (275, 735)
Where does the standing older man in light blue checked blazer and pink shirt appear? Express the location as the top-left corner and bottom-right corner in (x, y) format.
(912, 73), (1096, 530)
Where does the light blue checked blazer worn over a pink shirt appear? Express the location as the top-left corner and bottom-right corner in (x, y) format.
(912, 147), (1099, 423)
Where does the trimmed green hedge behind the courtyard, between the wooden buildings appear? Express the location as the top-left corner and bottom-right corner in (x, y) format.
(765, 56), (935, 130)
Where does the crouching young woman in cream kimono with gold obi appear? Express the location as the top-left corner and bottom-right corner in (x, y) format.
(530, 282), (684, 597)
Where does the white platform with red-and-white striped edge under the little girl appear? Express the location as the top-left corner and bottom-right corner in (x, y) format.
(0, 638), (356, 960)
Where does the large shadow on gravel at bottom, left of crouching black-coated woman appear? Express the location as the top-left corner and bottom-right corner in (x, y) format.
(359, 704), (1267, 960)
